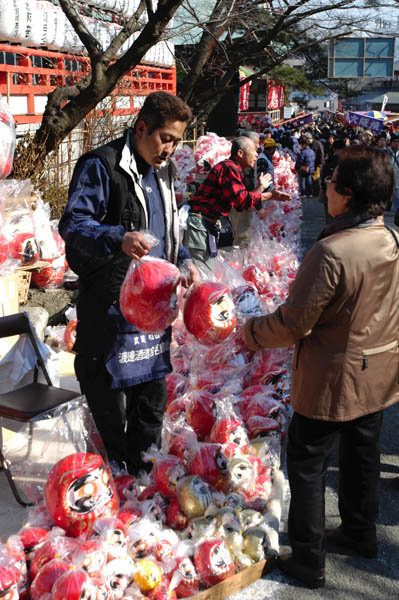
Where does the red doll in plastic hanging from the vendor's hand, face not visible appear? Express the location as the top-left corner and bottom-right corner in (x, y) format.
(120, 257), (181, 333)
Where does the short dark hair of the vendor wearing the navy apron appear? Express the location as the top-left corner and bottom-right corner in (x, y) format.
(135, 92), (192, 133)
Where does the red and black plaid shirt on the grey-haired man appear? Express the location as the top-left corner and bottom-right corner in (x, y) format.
(190, 158), (262, 218)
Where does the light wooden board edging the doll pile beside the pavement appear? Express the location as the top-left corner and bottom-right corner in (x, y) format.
(186, 556), (276, 600)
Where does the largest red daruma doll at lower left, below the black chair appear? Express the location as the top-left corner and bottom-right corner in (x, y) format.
(44, 452), (119, 537)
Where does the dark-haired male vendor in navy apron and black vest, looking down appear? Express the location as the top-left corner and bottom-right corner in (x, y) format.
(59, 92), (196, 473)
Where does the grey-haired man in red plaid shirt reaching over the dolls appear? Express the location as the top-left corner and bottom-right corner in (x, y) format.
(183, 137), (289, 276)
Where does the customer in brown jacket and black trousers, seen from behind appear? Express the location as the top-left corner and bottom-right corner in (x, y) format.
(243, 146), (399, 588)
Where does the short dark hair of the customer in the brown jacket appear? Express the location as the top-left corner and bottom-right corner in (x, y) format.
(335, 144), (394, 217)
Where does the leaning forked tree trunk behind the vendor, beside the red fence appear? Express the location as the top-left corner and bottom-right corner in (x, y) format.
(13, 0), (183, 180)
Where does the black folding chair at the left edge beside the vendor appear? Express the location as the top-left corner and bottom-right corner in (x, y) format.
(0, 312), (80, 506)
